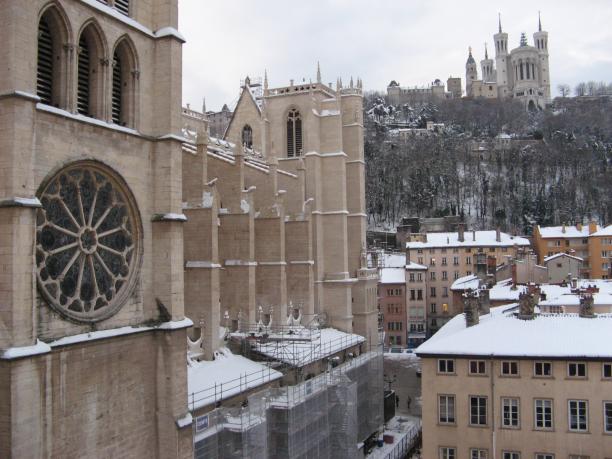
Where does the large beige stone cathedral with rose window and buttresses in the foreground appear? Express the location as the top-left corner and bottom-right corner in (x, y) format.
(0, 0), (377, 458)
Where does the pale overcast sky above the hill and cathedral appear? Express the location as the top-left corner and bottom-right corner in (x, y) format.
(179, 0), (612, 111)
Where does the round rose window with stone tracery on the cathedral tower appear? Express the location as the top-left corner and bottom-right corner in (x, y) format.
(36, 162), (140, 322)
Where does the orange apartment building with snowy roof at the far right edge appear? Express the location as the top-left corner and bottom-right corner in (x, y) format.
(533, 222), (612, 279)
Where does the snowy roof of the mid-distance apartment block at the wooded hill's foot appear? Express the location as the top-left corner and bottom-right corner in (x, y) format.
(406, 231), (529, 249)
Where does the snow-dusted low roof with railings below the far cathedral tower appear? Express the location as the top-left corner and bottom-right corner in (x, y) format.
(253, 328), (365, 367)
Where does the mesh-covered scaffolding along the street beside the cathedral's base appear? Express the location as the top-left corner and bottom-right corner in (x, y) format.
(194, 346), (383, 459)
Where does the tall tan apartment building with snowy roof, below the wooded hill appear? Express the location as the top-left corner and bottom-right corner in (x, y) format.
(406, 225), (529, 336)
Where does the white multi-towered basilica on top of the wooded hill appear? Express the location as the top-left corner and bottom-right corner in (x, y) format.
(465, 13), (551, 110)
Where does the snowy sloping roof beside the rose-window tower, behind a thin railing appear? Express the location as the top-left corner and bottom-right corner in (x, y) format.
(187, 349), (283, 409)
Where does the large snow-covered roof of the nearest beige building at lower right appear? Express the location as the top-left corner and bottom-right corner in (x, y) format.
(416, 304), (612, 358)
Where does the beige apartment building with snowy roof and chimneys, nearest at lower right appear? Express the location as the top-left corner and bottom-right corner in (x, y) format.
(417, 302), (612, 459)
